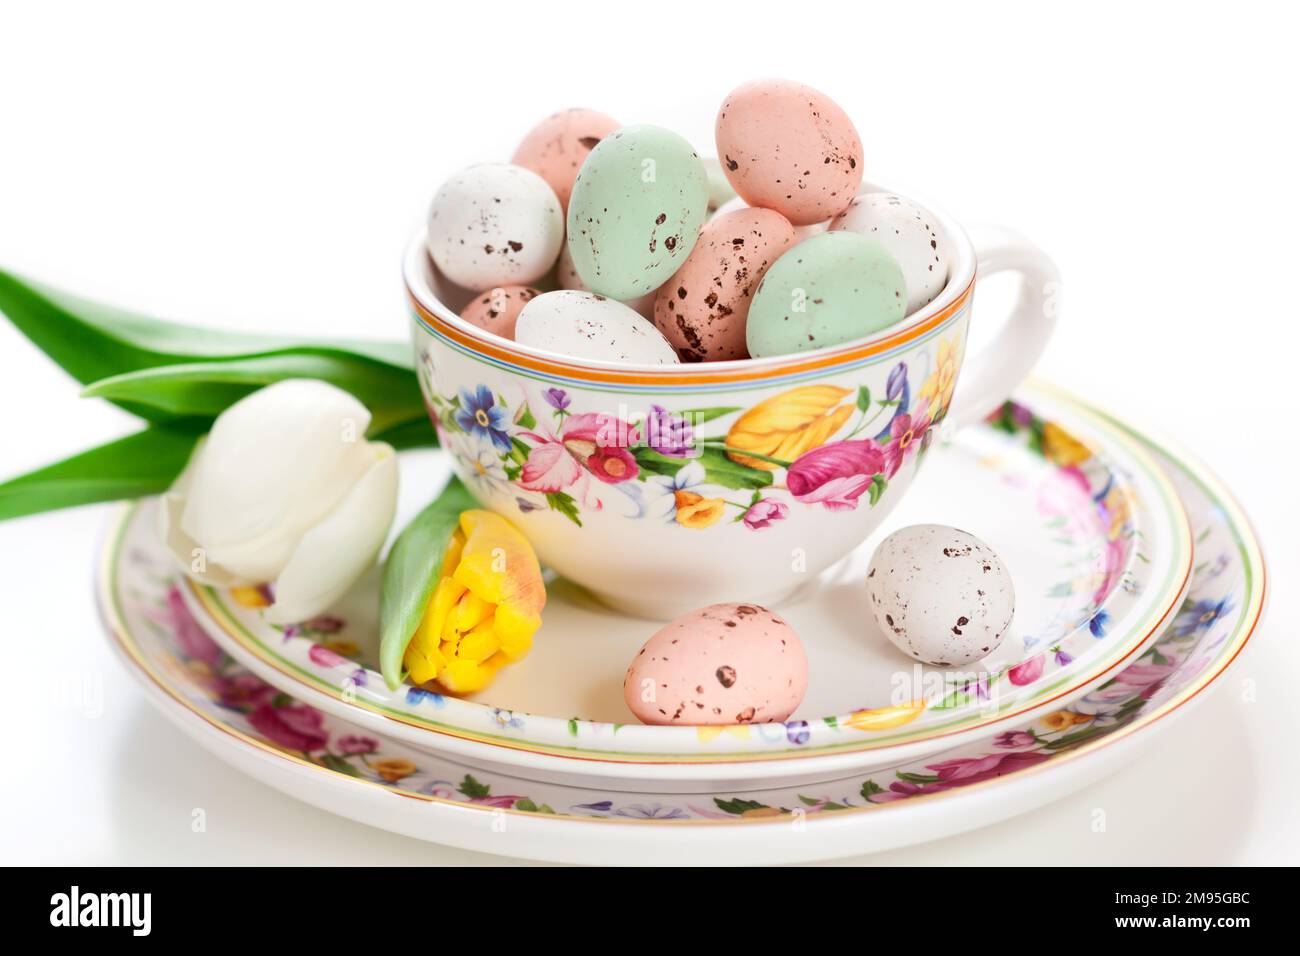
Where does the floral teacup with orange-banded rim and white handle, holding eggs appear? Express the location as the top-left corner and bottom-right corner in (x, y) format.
(406, 192), (1058, 619)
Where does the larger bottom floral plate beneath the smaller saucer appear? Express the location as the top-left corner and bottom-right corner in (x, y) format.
(98, 408), (1265, 864)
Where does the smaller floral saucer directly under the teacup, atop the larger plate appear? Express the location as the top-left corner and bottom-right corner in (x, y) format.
(170, 393), (1192, 791)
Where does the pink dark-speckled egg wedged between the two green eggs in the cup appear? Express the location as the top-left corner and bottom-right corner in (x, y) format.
(654, 207), (796, 362)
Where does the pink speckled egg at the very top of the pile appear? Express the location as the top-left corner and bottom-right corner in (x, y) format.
(715, 79), (862, 226)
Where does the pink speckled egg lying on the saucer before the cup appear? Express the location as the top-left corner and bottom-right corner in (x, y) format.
(623, 604), (809, 724)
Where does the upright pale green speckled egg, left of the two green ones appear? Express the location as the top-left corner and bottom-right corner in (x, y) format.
(568, 126), (709, 299)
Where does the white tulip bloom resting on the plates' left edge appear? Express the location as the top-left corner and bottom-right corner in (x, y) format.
(160, 378), (398, 624)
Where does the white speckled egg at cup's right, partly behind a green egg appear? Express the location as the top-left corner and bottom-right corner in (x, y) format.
(831, 193), (948, 315)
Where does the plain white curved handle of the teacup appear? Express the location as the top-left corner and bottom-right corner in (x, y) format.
(948, 226), (1061, 429)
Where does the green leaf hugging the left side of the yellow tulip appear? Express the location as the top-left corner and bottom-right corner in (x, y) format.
(380, 477), (478, 689)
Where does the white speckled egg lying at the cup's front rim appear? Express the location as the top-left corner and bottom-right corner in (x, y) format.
(515, 289), (677, 365)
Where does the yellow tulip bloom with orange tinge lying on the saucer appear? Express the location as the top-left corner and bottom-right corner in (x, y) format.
(402, 510), (546, 693)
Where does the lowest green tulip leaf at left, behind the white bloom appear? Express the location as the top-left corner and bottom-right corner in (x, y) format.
(0, 425), (202, 520)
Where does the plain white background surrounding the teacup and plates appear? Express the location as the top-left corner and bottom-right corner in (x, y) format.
(0, 0), (1300, 864)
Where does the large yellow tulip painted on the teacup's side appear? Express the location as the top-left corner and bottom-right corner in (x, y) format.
(727, 385), (854, 471)
